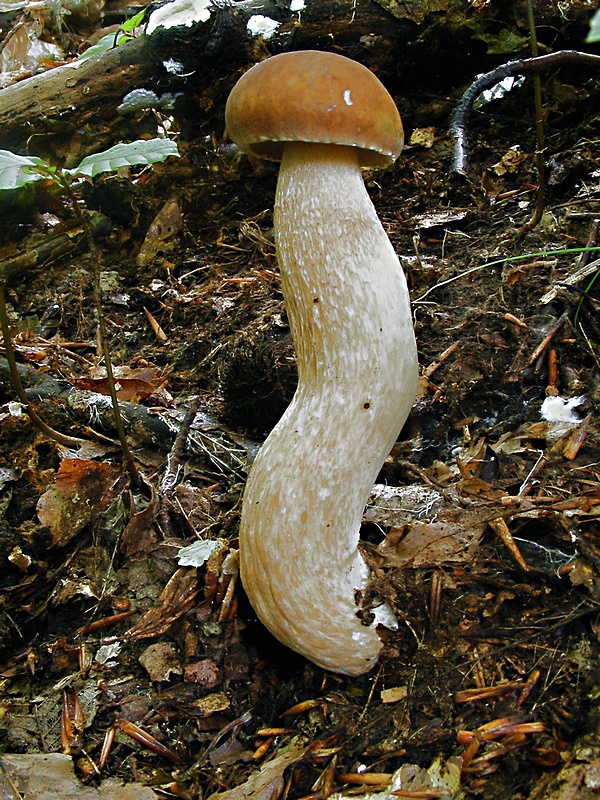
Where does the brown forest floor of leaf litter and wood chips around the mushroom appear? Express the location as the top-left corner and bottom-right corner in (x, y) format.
(0, 6), (600, 800)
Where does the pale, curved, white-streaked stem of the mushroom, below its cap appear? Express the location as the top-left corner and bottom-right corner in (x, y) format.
(240, 142), (417, 675)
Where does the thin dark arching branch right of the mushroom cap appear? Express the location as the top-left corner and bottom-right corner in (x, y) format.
(450, 50), (600, 175)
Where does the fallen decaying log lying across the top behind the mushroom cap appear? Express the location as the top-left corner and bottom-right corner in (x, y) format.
(0, 0), (591, 166)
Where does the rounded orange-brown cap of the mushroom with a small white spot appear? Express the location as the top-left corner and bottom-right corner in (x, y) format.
(225, 50), (404, 167)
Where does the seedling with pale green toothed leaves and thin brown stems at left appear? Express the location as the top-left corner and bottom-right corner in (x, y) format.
(0, 139), (179, 487)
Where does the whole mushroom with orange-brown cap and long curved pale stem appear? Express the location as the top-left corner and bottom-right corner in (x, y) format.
(226, 51), (418, 675)
